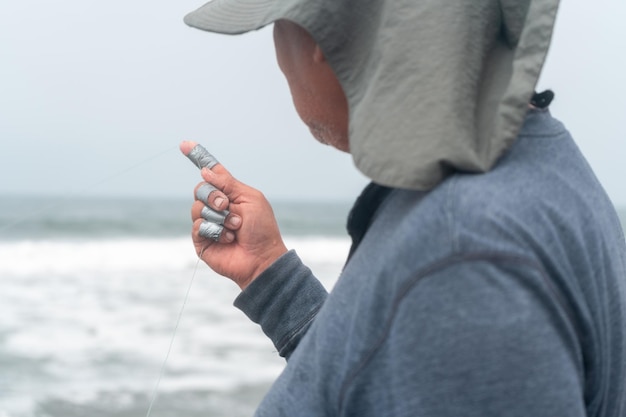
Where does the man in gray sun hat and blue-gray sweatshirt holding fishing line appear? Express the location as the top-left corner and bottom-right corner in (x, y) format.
(181, 0), (626, 417)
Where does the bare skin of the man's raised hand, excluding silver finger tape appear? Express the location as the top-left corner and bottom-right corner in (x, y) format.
(180, 142), (287, 290)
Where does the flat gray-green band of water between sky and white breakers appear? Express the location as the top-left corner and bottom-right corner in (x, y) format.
(0, 197), (349, 240)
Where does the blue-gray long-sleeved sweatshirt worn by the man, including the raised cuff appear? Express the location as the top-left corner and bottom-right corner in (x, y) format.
(235, 111), (626, 417)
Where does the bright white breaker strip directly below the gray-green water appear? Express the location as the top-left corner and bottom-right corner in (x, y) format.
(0, 236), (349, 276)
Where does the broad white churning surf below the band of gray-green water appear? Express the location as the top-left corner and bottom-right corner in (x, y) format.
(0, 237), (349, 416)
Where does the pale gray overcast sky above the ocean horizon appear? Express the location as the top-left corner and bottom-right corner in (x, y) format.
(0, 0), (626, 207)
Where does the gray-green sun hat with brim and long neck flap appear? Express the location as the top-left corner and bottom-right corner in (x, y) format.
(185, 0), (559, 190)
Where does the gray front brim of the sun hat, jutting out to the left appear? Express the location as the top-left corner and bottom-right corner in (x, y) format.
(184, 0), (276, 35)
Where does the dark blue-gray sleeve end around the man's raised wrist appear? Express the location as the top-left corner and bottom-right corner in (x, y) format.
(234, 250), (328, 359)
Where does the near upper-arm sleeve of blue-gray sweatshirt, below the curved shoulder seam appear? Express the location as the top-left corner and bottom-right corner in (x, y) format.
(344, 260), (586, 417)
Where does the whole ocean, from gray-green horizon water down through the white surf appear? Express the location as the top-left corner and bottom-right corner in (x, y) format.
(0, 196), (626, 417)
